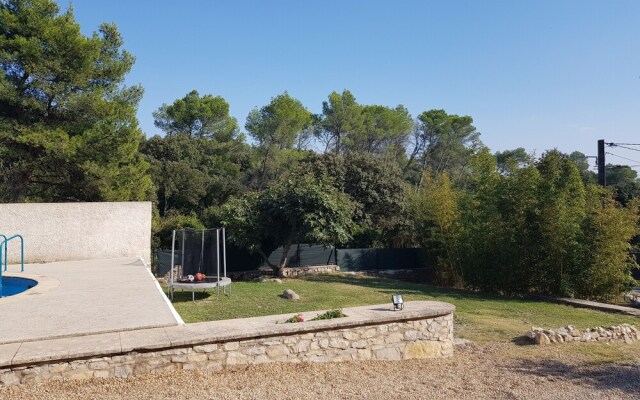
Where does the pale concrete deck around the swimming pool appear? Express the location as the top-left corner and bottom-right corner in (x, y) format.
(0, 257), (182, 344)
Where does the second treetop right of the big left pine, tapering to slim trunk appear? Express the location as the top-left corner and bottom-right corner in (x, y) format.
(245, 92), (312, 189)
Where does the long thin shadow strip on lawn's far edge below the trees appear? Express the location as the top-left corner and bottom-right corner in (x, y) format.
(302, 274), (521, 301)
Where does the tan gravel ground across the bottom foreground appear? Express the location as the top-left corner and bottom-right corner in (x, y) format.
(0, 344), (640, 400)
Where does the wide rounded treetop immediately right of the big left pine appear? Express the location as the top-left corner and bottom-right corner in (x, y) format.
(153, 90), (238, 142)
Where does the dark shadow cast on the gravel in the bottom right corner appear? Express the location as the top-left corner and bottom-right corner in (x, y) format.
(514, 360), (640, 398)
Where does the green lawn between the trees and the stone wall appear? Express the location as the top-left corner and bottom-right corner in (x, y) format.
(166, 274), (638, 343)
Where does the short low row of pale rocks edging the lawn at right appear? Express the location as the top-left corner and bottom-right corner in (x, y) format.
(524, 324), (639, 345)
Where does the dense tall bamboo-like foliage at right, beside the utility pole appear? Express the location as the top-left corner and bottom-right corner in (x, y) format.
(452, 150), (638, 299)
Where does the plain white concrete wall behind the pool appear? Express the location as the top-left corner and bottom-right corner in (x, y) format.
(0, 202), (151, 264)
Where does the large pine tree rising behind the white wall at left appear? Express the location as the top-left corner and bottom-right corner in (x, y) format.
(0, 0), (151, 202)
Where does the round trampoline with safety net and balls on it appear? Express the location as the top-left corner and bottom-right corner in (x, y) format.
(167, 228), (231, 301)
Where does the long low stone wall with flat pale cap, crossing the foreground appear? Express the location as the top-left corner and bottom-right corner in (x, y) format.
(0, 301), (455, 385)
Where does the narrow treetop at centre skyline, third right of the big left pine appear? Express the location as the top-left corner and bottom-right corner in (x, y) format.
(316, 89), (364, 154)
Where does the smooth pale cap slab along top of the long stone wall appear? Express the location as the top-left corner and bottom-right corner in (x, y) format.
(0, 301), (455, 368)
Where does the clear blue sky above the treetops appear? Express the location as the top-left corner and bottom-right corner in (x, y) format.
(59, 0), (640, 170)
